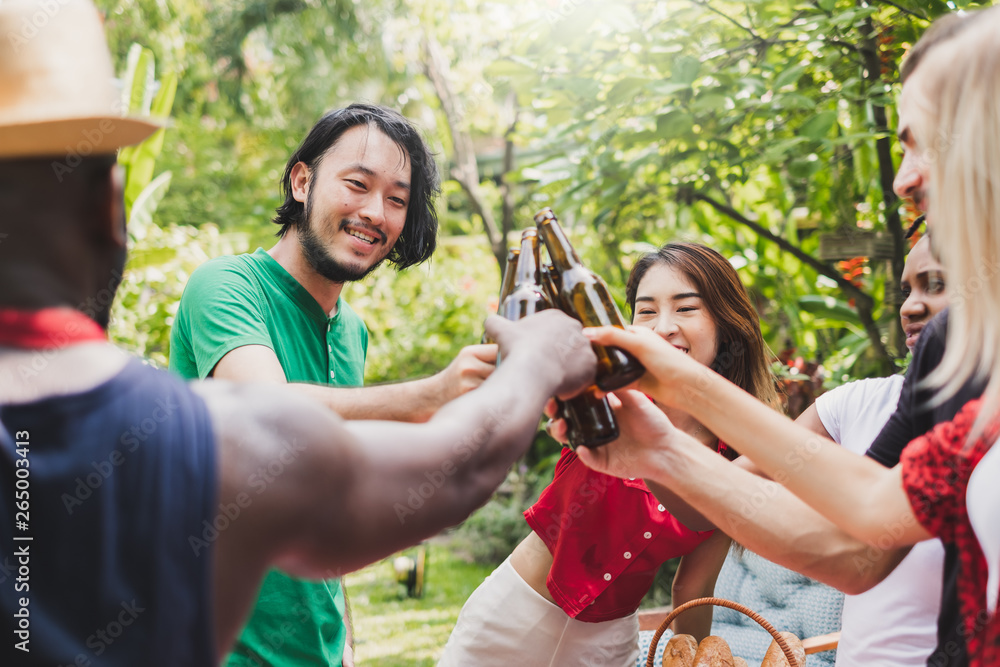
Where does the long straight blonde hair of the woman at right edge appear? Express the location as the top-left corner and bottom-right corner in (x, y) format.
(909, 7), (1000, 442)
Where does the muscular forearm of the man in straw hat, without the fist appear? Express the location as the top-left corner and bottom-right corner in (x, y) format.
(326, 357), (553, 567)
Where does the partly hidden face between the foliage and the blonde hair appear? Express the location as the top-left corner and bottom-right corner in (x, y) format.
(899, 236), (948, 352)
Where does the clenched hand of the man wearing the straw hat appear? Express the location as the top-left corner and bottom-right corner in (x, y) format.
(486, 309), (597, 398)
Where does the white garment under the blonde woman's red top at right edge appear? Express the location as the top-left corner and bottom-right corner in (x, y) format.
(965, 441), (1000, 614)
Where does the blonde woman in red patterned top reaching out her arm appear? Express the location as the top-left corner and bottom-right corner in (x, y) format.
(580, 6), (1000, 667)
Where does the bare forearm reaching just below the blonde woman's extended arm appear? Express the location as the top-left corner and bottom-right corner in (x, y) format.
(650, 434), (906, 594)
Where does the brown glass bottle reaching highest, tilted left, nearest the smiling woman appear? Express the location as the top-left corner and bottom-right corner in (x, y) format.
(535, 208), (646, 391)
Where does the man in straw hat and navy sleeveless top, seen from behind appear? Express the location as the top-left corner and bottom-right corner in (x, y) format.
(0, 0), (595, 667)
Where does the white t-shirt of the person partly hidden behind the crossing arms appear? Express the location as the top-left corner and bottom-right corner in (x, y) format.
(816, 375), (944, 667)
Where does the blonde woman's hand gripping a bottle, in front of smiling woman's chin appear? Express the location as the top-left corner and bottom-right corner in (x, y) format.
(583, 326), (713, 407)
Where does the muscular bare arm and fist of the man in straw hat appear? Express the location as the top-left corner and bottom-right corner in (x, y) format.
(199, 311), (596, 647)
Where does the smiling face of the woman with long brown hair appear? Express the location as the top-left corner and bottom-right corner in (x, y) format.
(632, 262), (718, 366)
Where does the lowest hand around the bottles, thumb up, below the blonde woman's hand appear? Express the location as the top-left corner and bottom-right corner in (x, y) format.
(576, 389), (685, 479)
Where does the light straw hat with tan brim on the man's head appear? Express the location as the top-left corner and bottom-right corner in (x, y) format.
(0, 0), (162, 159)
